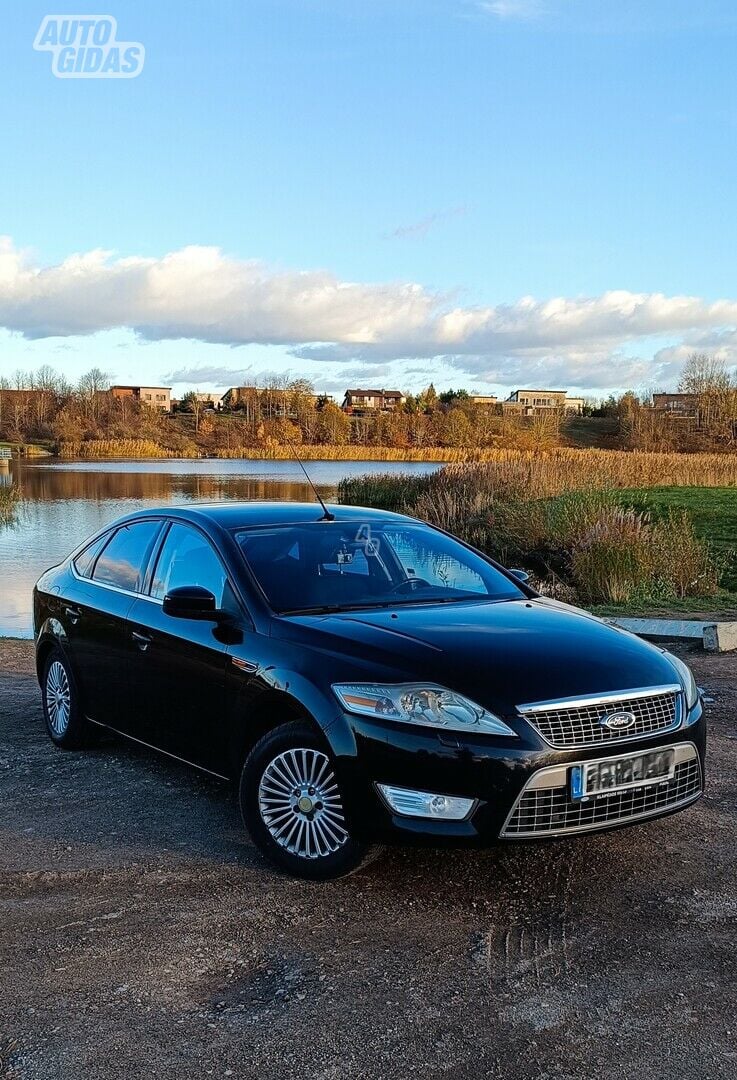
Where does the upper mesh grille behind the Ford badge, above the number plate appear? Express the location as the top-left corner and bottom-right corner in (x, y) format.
(520, 690), (679, 748)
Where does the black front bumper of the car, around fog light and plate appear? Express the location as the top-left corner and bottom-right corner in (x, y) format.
(330, 703), (706, 845)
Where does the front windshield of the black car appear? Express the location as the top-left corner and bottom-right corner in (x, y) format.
(235, 521), (525, 613)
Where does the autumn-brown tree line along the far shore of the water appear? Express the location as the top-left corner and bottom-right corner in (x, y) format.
(0, 354), (737, 454)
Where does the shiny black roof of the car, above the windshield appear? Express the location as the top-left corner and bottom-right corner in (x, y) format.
(112, 500), (415, 529)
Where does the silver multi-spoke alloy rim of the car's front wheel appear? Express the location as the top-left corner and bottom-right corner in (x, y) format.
(258, 747), (349, 859)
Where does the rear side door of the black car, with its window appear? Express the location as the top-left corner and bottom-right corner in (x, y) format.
(64, 518), (162, 728)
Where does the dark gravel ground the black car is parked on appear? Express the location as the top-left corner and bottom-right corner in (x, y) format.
(0, 640), (737, 1080)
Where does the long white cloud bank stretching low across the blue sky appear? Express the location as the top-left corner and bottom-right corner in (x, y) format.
(0, 239), (737, 399)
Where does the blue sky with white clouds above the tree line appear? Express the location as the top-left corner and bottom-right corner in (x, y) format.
(0, 0), (737, 397)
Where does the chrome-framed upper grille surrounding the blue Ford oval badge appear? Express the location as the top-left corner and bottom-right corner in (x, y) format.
(518, 683), (682, 750)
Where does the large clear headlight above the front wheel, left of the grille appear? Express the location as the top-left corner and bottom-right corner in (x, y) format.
(333, 683), (515, 735)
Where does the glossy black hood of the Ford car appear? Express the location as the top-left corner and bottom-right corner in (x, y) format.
(273, 597), (678, 714)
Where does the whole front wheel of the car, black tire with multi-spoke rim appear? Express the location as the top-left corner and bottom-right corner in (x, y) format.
(239, 721), (381, 881)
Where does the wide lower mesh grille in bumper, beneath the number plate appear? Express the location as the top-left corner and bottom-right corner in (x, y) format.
(501, 751), (702, 837)
